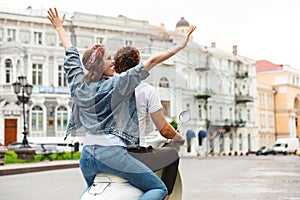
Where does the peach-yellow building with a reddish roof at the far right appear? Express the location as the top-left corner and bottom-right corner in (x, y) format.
(257, 60), (300, 142)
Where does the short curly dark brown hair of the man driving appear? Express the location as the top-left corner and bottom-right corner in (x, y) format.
(114, 46), (140, 74)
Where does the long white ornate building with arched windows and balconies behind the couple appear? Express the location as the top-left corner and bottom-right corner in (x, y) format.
(0, 9), (258, 154)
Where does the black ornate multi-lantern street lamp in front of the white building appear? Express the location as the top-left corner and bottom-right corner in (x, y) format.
(12, 76), (32, 148)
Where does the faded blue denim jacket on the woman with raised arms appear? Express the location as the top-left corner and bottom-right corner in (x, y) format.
(64, 47), (149, 144)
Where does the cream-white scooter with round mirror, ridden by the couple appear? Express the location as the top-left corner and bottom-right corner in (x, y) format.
(81, 111), (190, 200)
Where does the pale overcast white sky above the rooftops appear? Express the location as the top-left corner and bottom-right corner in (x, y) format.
(0, 0), (300, 69)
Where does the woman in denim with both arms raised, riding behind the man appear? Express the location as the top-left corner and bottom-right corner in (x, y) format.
(48, 9), (196, 200)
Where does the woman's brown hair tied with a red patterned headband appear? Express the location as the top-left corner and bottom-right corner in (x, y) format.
(82, 45), (105, 83)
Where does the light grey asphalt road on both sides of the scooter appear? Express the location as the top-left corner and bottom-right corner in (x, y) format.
(0, 155), (300, 200)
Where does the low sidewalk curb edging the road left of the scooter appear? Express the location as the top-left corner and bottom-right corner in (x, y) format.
(0, 160), (79, 176)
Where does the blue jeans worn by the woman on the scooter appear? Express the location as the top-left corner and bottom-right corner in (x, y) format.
(80, 145), (168, 200)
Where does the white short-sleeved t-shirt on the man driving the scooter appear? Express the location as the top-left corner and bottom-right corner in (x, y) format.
(135, 82), (163, 147)
